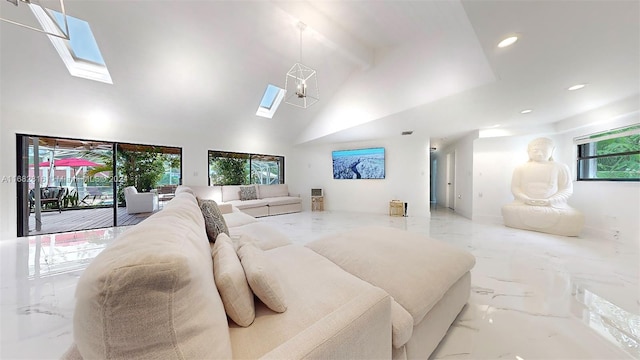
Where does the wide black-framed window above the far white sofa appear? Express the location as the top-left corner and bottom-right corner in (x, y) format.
(209, 151), (284, 185)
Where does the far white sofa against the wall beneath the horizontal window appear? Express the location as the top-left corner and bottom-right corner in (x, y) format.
(189, 184), (302, 217)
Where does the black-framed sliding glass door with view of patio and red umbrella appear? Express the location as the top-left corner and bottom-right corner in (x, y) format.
(16, 134), (182, 236)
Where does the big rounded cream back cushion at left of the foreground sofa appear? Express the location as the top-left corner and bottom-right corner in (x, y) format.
(73, 193), (232, 359)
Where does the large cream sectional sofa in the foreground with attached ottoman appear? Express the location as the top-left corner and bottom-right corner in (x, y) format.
(64, 187), (475, 359)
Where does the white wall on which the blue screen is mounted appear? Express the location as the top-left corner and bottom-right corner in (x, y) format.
(287, 136), (430, 216)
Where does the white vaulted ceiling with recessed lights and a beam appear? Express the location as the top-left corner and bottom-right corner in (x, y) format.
(0, 0), (640, 149)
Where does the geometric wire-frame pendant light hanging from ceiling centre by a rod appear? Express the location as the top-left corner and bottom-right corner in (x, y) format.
(284, 22), (320, 109)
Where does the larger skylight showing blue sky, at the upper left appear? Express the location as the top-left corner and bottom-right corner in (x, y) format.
(29, 4), (113, 84)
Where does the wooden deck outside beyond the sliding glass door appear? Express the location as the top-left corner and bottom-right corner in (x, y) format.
(29, 207), (159, 235)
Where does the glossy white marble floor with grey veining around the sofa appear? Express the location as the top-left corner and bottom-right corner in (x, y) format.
(0, 209), (640, 360)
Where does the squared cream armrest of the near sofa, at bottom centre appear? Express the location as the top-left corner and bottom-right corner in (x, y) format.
(261, 287), (392, 359)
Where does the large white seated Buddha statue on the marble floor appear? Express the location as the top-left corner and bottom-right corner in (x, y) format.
(502, 138), (584, 236)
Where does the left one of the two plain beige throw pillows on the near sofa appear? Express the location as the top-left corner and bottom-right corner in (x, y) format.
(211, 233), (256, 327)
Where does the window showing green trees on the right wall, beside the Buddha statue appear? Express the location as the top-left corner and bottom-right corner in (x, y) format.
(576, 125), (640, 181)
